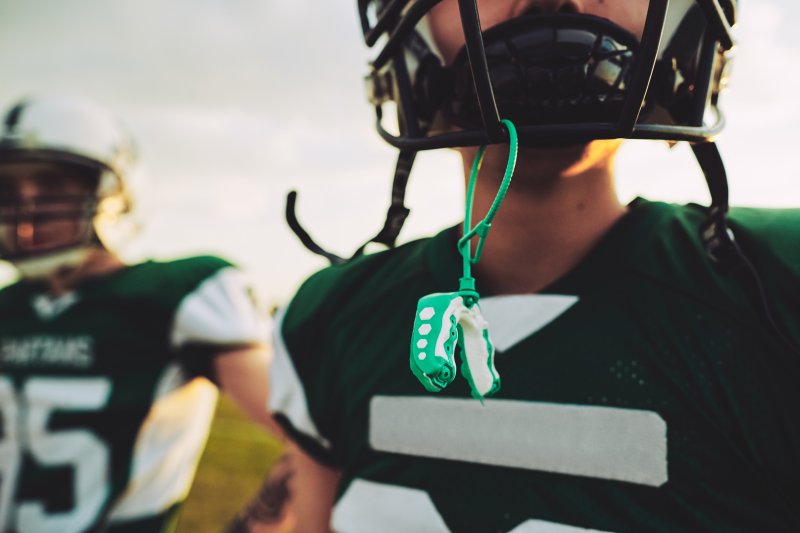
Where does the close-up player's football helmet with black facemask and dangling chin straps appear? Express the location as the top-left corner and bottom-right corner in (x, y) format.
(287, 0), (737, 263)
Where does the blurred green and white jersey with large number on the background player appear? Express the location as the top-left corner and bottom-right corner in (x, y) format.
(0, 257), (266, 533)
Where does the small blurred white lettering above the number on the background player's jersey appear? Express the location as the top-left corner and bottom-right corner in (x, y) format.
(0, 335), (94, 368)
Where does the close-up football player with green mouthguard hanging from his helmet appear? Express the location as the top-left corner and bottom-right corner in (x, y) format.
(270, 0), (800, 533)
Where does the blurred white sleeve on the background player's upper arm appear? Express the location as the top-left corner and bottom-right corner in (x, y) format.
(170, 267), (269, 348)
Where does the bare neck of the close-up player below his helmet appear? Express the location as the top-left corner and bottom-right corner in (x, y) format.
(466, 145), (627, 294)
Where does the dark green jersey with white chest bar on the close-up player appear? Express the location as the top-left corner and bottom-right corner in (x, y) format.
(270, 200), (800, 533)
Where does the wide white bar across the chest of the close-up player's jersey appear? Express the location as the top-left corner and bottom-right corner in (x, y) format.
(369, 396), (668, 487)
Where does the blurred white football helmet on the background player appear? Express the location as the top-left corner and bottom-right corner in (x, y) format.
(0, 97), (138, 277)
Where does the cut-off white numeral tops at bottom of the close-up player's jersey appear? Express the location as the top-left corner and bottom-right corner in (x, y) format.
(331, 479), (602, 533)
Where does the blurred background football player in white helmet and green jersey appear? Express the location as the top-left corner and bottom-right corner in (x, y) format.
(0, 98), (272, 533)
